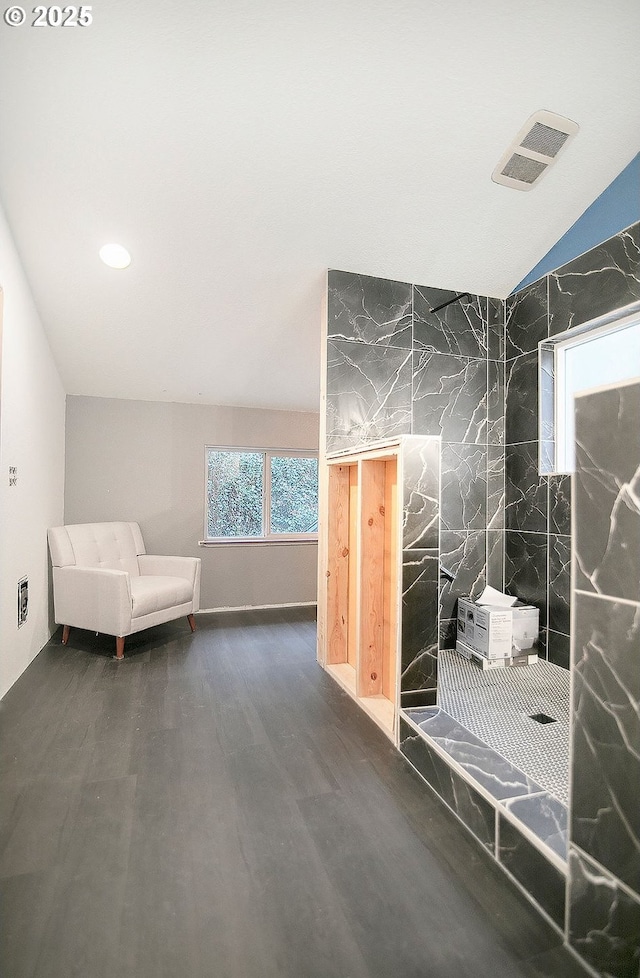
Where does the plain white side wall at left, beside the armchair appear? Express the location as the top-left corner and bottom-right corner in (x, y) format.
(0, 202), (65, 696)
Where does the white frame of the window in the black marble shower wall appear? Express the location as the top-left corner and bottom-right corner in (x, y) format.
(538, 301), (640, 475)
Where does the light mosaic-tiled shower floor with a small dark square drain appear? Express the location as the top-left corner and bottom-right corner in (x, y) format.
(438, 651), (569, 805)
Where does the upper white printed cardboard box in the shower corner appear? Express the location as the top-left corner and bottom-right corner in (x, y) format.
(456, 598), (540, 659)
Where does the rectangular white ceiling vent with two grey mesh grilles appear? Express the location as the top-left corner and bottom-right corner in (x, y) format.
(491, 109), (580, 190)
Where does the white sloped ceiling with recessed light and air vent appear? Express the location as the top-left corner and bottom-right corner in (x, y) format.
(0, 0), (640, 411)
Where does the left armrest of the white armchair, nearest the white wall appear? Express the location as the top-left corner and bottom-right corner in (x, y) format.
(53, 566), (131, 635)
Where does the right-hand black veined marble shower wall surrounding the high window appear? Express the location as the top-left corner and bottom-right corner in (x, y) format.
(504, 224), (640, 668)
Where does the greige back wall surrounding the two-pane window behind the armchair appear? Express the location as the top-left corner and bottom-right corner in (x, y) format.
(65, 395), (319, 609)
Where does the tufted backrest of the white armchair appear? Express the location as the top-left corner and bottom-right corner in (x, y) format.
(48, 523), (146, 577)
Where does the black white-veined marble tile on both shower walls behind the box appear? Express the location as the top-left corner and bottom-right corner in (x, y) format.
(326, 224), (640, 692)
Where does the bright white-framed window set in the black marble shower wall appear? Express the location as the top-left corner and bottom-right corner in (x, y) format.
(539, 303), (640, 473)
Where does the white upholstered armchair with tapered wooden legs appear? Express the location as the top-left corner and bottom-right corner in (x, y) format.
(48, 523), (200, 659)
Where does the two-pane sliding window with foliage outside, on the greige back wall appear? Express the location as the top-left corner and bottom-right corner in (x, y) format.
(205, 448), (318, 542)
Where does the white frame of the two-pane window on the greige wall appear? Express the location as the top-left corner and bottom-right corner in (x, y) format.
(200, 445), (319, 547)
